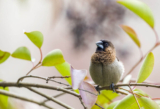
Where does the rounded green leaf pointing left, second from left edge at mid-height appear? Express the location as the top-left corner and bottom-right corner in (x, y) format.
(11, 47), (31, 61)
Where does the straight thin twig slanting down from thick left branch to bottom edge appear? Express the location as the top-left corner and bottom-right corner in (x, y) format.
(27, 87), (73, 109)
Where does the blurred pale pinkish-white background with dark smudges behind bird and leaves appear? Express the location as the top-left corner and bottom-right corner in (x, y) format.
(0, 0), (160, 109)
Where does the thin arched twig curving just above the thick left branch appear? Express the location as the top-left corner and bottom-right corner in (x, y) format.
(17, 75), (70, 86)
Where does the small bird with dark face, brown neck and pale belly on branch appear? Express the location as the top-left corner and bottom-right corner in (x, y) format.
(89, 40), (124, 91)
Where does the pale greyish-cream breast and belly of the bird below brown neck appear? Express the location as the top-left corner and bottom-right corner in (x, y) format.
(90, 59), (124, 86)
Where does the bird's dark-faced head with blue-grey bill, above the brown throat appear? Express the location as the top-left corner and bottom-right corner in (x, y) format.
(96, 40), (115, 52)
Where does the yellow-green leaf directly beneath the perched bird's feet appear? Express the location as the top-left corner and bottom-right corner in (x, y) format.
(92, 90), (119, 109)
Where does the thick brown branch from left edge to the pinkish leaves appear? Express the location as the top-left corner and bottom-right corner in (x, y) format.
(0, 82), (80, 97)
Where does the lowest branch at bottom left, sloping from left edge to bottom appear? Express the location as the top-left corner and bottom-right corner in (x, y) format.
(0, 90), (53, 109)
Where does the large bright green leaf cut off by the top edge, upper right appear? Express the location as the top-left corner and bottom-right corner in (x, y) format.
(117, 0), (154, 28)
